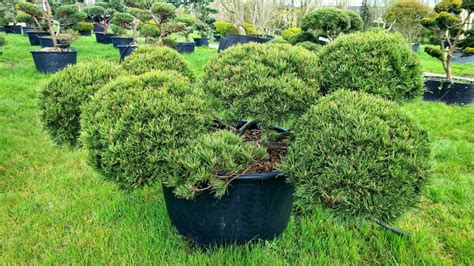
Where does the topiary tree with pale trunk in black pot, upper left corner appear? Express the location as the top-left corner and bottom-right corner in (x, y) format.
(23, 0), (85, 73)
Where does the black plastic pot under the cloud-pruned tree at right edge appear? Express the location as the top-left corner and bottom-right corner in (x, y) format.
(423, 79), (474, 105)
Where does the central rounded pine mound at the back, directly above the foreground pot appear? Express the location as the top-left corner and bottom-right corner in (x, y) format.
(203, 43), (319, 124)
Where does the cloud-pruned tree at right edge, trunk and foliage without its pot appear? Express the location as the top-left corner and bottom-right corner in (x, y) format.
(422, 0), (474, 80)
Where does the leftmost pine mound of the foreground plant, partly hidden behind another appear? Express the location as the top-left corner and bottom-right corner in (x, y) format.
(39, 60), (126, 146)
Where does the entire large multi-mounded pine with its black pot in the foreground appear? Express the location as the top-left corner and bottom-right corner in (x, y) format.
(40, 29), (429, 246)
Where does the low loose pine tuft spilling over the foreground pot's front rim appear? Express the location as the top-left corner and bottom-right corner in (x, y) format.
(162, 130), (267, 199)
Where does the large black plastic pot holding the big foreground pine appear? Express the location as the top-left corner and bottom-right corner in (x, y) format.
(163, 172), (293, 246)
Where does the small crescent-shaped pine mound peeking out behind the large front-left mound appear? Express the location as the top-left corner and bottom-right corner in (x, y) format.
(122, 46), (195, 80)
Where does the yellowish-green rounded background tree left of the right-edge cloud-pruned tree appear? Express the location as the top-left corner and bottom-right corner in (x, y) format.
(384, 0), (429, 43)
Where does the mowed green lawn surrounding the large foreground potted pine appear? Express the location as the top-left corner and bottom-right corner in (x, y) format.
(0, 35), (474, 265)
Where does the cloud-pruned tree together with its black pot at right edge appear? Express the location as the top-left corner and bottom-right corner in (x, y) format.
(422, 0), (474, 105)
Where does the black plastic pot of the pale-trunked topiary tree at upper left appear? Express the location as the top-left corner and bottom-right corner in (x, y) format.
(31, 49), (77, 73)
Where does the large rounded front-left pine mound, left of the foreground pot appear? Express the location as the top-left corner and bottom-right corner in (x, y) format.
(81, 71), (211, 189)
